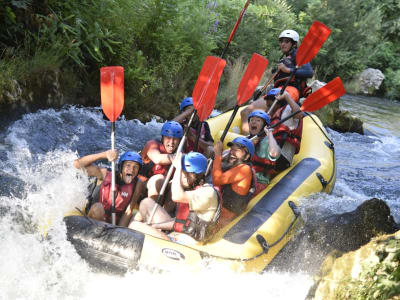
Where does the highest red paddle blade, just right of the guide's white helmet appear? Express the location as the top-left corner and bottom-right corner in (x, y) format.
(296, 21), (331, 67)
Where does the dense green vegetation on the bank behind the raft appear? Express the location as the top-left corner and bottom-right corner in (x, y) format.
(0, 0), (400, 120)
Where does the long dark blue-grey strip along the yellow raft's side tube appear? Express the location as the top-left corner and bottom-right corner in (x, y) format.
(224, 158), (321, 244)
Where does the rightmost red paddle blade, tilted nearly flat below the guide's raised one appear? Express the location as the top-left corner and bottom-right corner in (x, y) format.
(300, 77), (346, 112)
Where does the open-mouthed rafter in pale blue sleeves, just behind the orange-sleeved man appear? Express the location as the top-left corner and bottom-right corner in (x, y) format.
(248, 110), (281, 196)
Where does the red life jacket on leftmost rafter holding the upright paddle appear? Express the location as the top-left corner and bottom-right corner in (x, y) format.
(99, 171), (137, 219)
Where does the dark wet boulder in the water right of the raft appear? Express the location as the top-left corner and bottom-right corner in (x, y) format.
(305, 198), (400, 252)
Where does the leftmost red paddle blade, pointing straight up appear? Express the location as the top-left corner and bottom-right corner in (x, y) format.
(100, 67), (124, 122)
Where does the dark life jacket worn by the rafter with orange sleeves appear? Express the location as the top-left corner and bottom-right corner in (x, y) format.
(221, 163), (256, 215)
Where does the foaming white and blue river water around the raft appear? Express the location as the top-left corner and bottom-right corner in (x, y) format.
(0, 95), (400, 300)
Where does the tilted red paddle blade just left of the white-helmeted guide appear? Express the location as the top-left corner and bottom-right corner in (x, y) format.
(237, 53), (268, 106)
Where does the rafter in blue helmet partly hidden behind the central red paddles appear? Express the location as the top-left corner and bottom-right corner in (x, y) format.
(173, 97), (214, 157)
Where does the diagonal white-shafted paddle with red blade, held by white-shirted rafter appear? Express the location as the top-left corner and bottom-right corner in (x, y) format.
(147, 56), (226, 225)
